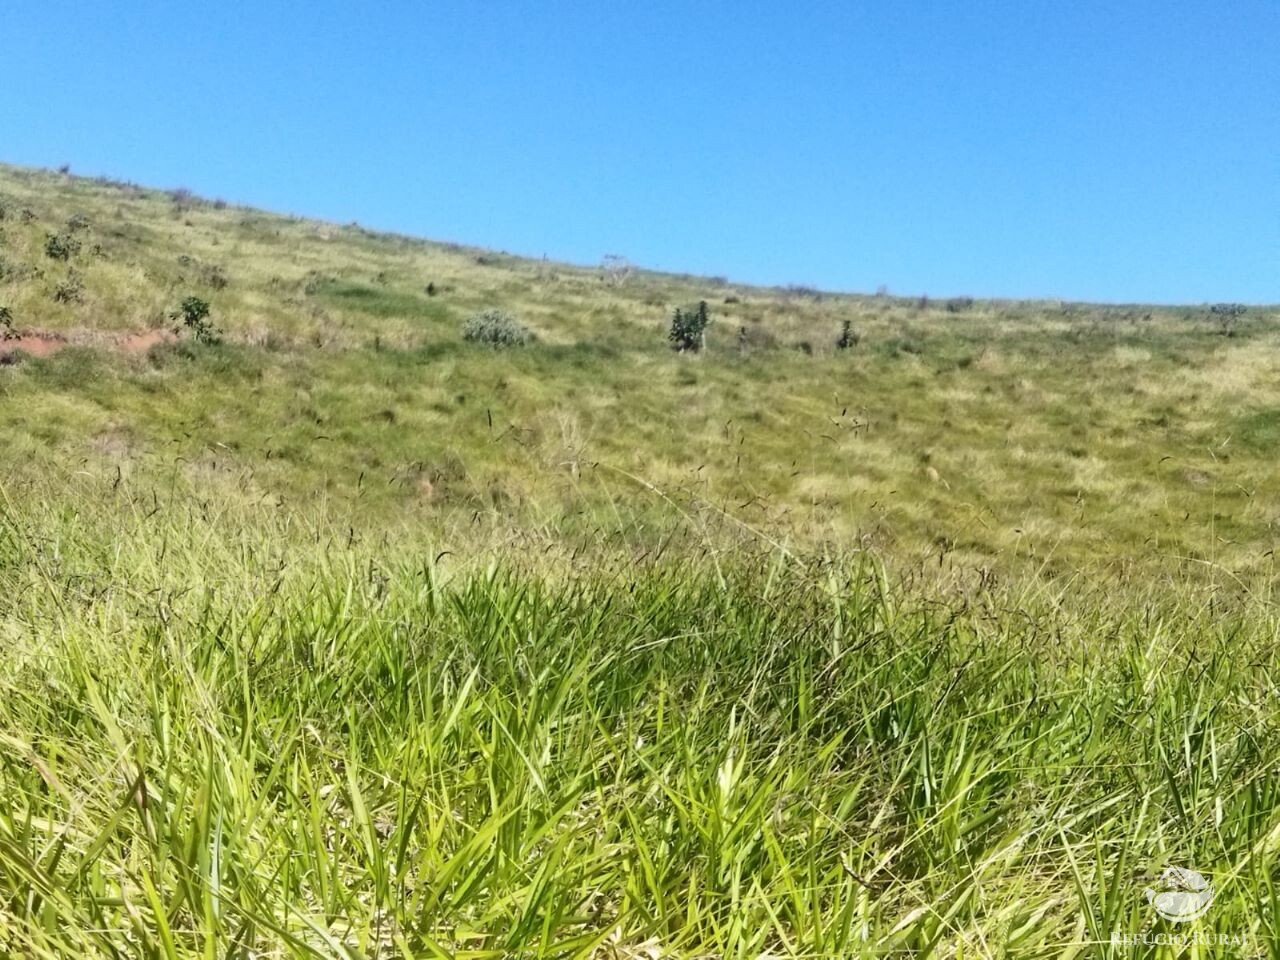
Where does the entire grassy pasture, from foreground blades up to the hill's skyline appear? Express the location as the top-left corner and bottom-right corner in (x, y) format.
(0, 161), (1280, 960)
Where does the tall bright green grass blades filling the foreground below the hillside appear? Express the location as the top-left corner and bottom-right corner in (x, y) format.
(0, 509), (1280, 957)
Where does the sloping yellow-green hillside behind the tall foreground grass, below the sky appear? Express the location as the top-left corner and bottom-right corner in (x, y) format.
(0, 168), (1280, 572)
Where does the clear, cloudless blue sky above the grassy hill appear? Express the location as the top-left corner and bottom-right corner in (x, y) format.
(0, 0), (1280, 302)
